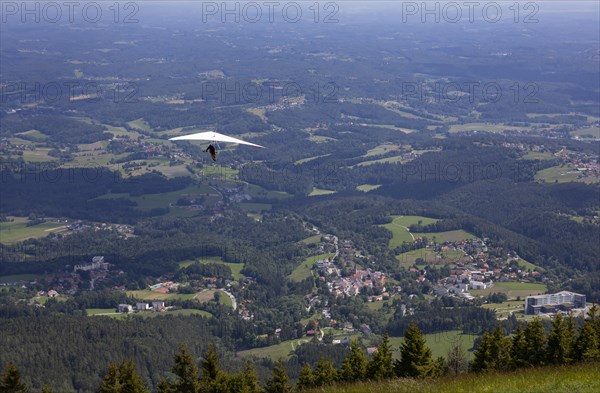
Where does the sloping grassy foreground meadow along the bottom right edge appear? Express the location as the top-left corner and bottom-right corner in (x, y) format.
(307, 362), (600, 393)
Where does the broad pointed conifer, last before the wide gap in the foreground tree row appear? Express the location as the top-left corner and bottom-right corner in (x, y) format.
(394, 321), (433, 377)
